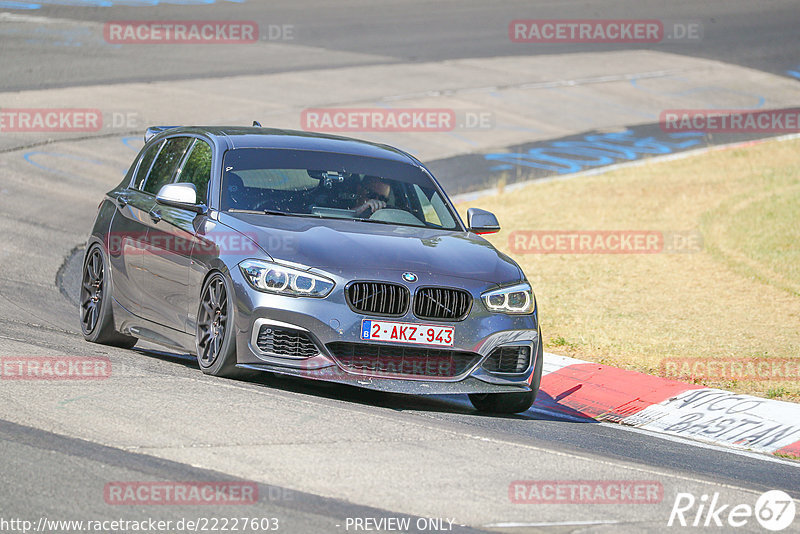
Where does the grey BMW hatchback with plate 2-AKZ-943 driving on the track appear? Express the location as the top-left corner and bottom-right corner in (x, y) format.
(80, 127), (542, 413)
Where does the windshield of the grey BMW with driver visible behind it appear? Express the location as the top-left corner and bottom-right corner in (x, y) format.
(221, 148), (460, 230)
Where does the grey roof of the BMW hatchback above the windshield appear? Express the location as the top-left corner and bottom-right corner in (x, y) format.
(148, 126), (419, 165)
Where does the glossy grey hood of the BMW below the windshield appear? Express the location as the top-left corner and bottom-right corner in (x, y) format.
(220, 213), (523, 284)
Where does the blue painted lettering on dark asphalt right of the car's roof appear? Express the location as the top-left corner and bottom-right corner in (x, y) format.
(484, 130), (704, 174)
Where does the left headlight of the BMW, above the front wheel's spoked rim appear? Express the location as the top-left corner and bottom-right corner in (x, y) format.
(239, 260), (335, 298)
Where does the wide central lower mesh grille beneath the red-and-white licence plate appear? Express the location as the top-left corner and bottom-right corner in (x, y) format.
(327, 341), (480, 378)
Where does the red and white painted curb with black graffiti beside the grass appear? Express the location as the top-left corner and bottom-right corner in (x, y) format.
(535, 353), (800, 457)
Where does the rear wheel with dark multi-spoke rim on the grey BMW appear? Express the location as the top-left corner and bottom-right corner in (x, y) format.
(79, 245), (138, 349)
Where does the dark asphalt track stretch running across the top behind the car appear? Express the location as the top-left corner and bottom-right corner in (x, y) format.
(0, 0), (800, 90)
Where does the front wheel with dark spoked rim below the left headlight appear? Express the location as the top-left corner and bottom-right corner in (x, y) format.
(195, 272), (242, 378)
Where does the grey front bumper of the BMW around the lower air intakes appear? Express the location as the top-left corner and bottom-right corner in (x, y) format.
(230, 269), (542, 394)
